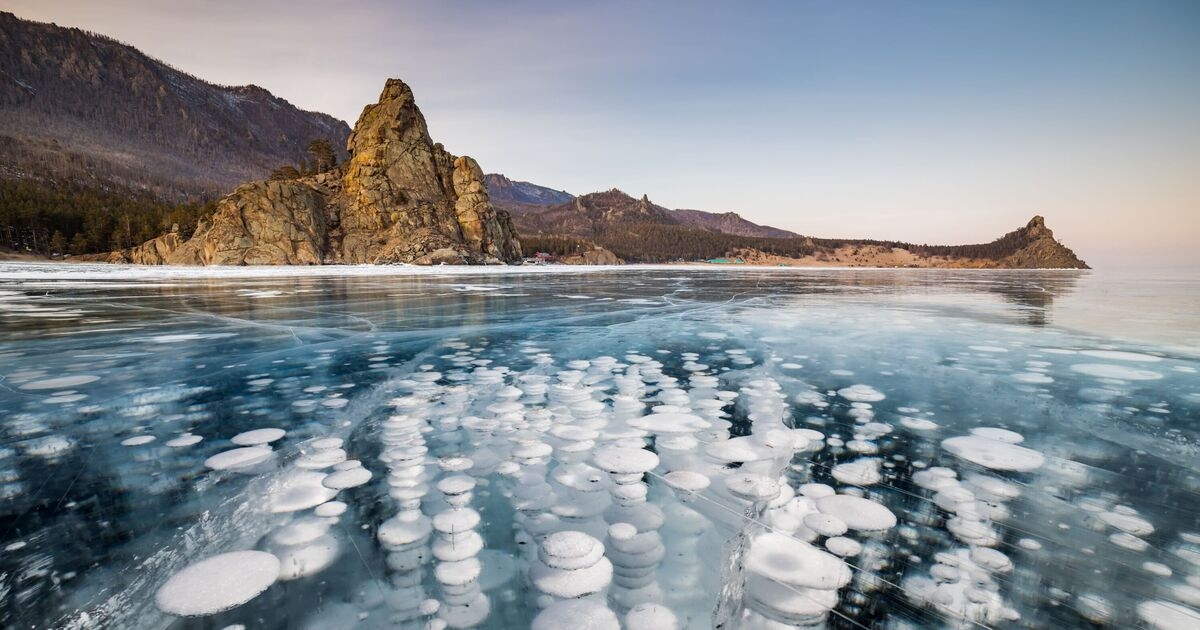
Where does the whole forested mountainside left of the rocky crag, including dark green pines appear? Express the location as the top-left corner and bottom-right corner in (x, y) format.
(0, 12), (349, 253)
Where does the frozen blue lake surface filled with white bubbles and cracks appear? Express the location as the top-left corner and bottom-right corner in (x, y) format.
(0, 263), (1200, 630)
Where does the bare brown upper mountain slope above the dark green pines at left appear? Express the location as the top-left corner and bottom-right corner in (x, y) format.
(0, 12), (350, 202)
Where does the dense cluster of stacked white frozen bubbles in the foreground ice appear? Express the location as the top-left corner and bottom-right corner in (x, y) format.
(140, 340), (1200, 630)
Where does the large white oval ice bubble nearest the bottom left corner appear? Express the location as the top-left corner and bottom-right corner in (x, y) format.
(155, 551), (280, 617)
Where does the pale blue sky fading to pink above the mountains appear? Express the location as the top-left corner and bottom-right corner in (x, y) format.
(0, 0), (1200, 268)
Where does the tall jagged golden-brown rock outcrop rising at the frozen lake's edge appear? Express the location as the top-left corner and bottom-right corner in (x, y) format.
(114, 79), (521, 265)
